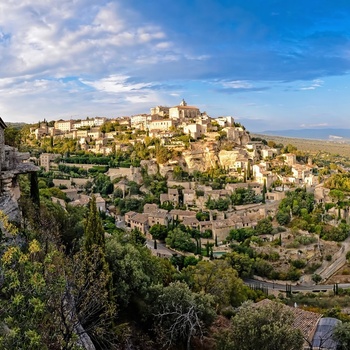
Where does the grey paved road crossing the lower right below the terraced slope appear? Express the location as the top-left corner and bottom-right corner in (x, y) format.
(244, 278), (350, 293)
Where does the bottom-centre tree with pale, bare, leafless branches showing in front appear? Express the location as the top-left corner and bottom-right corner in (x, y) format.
(149, 282), (216, 350)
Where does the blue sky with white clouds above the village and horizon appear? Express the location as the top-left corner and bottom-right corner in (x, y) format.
(0, 0), (350, 132)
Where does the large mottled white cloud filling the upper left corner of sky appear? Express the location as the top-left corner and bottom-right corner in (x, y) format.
(0, 0), (170, 77)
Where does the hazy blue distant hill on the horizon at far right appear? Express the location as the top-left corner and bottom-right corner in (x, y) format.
(257, 129), (350, 141)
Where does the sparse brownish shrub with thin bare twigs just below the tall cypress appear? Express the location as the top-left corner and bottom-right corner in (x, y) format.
(71, 245), (117, 349)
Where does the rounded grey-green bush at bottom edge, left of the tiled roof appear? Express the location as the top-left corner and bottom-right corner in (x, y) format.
(217, 302), (303, 350)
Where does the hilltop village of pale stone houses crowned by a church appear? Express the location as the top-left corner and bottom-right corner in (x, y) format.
(26, 100), (325, 241)
